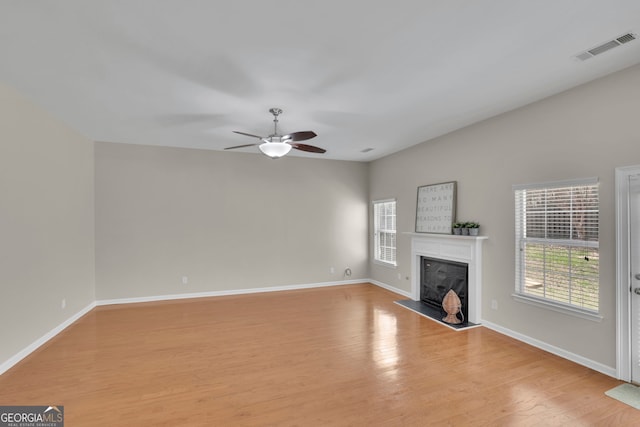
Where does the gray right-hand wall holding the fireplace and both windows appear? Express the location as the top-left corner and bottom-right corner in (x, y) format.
(370, 62), (640, 367)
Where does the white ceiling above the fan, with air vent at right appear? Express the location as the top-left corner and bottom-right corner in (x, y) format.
(0, 0), (640, 161)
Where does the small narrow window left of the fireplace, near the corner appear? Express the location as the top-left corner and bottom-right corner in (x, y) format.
(373, 200), (396, 266)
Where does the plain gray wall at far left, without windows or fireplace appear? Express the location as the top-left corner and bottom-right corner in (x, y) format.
(0, 85), (95, 363)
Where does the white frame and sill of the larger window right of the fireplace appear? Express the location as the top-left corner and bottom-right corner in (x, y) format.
(512, 178), (603, 321)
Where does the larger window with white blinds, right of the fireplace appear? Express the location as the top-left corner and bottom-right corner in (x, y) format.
(513, 178), (600, 313)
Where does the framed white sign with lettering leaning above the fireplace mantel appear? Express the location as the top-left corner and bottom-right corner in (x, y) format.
(416, 181), (456, 234)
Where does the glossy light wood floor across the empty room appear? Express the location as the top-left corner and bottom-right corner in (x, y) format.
(0, 284), (640, 427)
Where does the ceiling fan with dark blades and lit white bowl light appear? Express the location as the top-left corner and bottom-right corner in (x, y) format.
(225, 108), (327, 159)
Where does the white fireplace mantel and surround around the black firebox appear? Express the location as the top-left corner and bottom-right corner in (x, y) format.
(402, 232), (488, 323)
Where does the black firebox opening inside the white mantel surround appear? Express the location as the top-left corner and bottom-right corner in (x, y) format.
(420, 256), (469, 321)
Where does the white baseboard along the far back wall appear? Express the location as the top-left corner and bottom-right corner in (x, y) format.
(96, 279), (370, 306)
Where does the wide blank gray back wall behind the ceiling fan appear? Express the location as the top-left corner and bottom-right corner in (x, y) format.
(95, 142), (369, 300)
